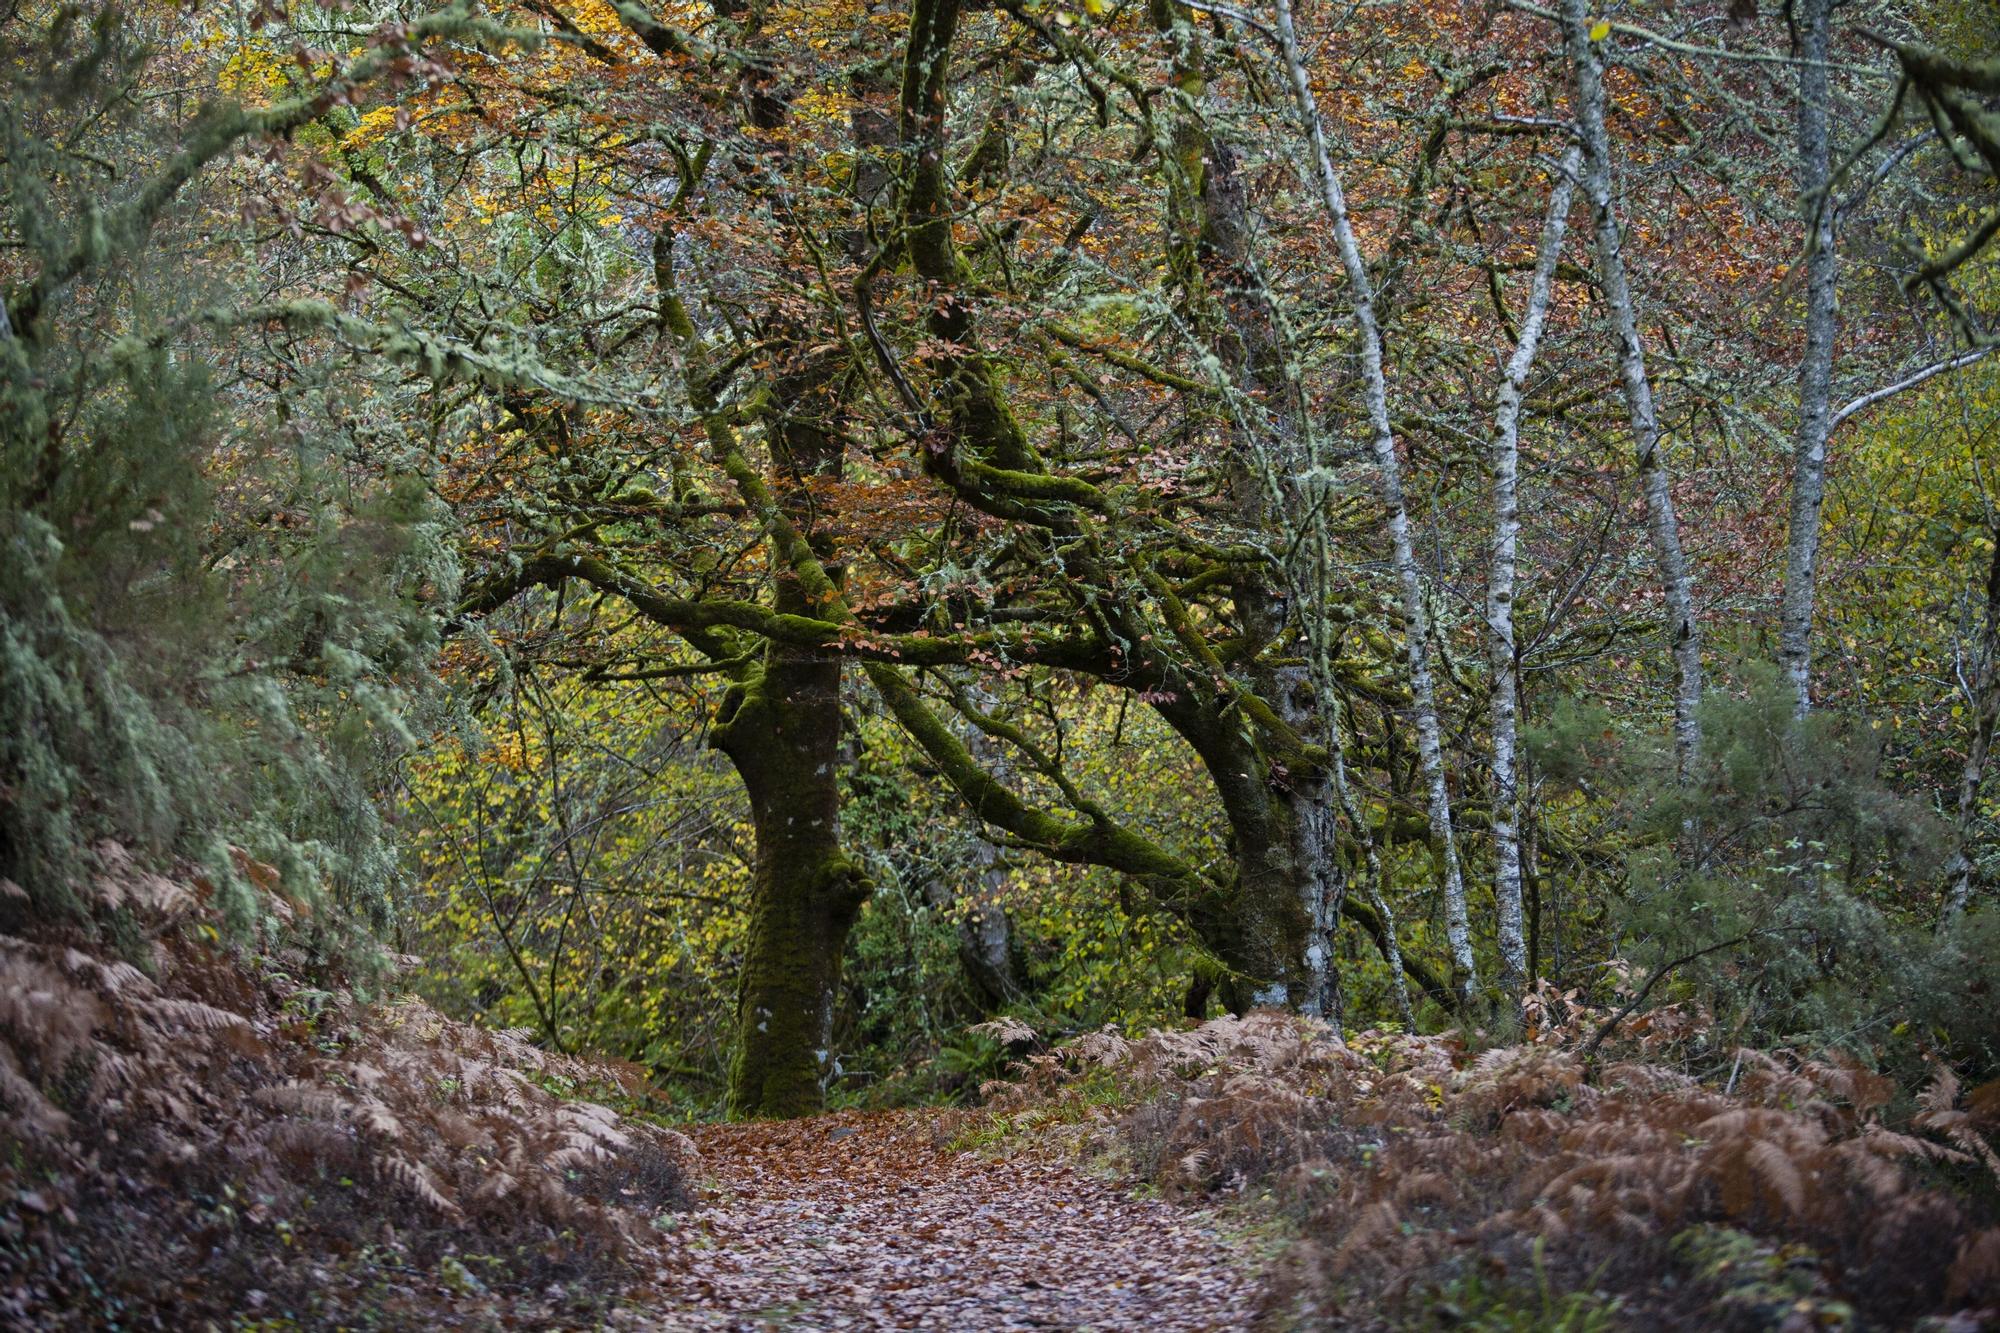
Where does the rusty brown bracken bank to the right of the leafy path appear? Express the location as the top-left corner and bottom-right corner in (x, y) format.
(960, 1013), (2000, 1329)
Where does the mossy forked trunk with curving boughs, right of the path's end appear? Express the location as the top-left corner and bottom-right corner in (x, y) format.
(900, 0), (1340, 1011)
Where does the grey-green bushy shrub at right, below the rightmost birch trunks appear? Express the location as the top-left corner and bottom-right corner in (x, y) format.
(1526, 662), (2000, 1083)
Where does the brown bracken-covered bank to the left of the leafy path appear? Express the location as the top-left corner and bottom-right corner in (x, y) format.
(0, 847), (696, 1327)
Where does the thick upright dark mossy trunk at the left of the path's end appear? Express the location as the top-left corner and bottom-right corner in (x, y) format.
(628, 18), (894, 1117)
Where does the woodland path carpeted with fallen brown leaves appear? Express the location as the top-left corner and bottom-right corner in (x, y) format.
(664, 1113), (1258, 1333)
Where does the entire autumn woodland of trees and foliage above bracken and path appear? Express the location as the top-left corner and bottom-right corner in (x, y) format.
(0, 0), (2000, 1115)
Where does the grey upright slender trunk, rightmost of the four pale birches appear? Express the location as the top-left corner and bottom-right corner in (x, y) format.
(1778, 0), (1838, 715)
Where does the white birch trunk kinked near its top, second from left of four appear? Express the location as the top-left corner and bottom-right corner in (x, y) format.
(1486, 148), (1582, 1001)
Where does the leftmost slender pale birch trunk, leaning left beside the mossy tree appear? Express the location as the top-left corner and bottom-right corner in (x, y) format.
(1278, 0), (1478, 1001)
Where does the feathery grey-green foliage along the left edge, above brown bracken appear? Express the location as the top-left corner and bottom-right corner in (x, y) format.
(0, 10), (456, 943)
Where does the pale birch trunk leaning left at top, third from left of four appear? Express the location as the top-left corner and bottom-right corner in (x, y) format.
(1562, 0), (1702, 781)
